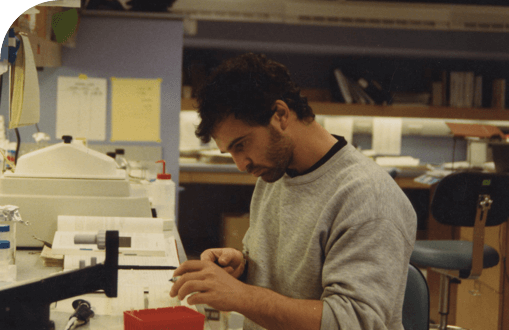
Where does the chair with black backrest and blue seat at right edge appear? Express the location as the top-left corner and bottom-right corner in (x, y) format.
(410, 172), (509, 330)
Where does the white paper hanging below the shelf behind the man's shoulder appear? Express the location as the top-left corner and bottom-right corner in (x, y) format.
(372, 117), (403, 155)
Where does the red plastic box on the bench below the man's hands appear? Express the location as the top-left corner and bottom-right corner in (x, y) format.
(124, 306), (205, 330)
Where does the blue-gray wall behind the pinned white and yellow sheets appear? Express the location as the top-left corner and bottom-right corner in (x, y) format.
(0, 16), (183, 184)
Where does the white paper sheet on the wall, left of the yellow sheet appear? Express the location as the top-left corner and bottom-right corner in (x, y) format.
(56, 75), (107, 141)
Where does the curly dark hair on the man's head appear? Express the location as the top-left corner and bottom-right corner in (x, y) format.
(195, 53), (315, 143)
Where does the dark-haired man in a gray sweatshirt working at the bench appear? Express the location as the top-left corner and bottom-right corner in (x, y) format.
(170, 54), (416, 330)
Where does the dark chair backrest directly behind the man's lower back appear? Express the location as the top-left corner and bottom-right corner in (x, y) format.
(403, 264), (429, 330)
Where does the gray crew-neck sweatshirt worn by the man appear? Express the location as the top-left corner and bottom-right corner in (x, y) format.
(243, 144), (417, 330)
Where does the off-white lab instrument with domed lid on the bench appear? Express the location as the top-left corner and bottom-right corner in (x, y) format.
(0, 140), (151, 246)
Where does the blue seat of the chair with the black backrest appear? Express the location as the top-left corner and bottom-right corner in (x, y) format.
(410, 240), (499, 277)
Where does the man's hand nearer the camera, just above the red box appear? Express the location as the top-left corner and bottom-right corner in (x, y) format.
(170, 260), (246, 311)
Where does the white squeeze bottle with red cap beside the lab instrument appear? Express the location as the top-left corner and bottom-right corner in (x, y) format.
(149, 160), (175, 219)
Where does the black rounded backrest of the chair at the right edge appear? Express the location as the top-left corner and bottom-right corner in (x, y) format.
(431, 172), (509, 227)
